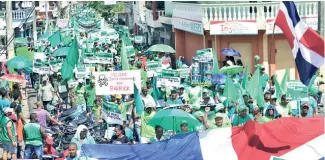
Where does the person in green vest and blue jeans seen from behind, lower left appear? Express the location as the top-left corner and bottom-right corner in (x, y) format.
(24, 113), (47, 159)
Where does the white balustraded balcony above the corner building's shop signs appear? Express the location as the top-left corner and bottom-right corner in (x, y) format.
(172, 1), (318, 30)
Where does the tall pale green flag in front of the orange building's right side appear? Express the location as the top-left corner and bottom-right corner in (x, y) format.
(246, 68), (265, 107)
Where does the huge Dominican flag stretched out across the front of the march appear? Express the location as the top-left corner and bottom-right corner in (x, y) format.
(82, 118), (325, 160)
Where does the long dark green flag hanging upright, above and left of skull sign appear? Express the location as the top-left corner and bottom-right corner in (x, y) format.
(61, 37), (79, 79)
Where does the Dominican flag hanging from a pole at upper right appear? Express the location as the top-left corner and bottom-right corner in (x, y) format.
(275, 1), (324, 86)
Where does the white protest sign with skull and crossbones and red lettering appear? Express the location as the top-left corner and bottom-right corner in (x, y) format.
(94, 70), (141, 95)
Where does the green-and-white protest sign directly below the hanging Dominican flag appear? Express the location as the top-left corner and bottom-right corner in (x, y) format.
(287, 81), (308, 100)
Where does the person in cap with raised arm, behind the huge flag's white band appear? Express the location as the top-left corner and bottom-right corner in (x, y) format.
(204, 107), (231, 130)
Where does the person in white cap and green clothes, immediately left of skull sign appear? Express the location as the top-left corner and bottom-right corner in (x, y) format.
(74, 79), (86, 111)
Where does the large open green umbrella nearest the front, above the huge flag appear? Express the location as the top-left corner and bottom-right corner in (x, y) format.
(148, 109), (200, 131)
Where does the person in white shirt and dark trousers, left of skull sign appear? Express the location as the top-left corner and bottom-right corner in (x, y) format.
(40, 80), (55, 108)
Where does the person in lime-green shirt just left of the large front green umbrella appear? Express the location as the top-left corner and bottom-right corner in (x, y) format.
(140, 106), (156, 143)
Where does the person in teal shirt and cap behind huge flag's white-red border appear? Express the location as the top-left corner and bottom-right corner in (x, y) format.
(232, 104), (254, 126)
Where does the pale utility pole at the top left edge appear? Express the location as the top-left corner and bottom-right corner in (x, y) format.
(6, 1), (15, 59)
